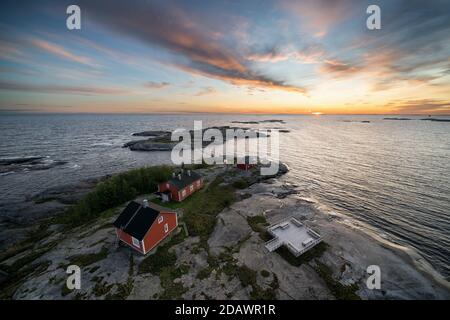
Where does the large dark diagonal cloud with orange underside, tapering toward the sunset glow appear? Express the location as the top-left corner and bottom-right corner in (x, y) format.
(77, 0), (305, 93)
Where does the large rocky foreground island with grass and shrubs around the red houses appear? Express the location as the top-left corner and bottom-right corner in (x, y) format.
(0, 164), (450, 299)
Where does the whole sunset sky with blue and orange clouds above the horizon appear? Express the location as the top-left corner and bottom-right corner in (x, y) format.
(0, 0), (450, 114)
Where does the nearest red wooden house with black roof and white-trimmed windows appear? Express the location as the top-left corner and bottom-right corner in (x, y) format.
(113, 200), (178, 254)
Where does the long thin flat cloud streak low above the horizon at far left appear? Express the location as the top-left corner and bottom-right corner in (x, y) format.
(0, 81), (129, 95)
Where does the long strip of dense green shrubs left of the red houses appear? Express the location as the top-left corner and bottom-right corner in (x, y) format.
(55, 166), (172, 227)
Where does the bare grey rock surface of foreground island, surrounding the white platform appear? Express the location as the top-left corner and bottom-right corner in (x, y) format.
(0, 162), (450, 299)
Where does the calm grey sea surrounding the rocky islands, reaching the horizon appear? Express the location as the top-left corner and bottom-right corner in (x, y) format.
(0, 113), (450, 279)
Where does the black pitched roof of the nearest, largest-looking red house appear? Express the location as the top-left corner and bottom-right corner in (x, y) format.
(113, 201), (170, 240)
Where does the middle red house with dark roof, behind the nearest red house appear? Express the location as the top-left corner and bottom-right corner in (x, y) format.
(158, 170), (203, 202)
